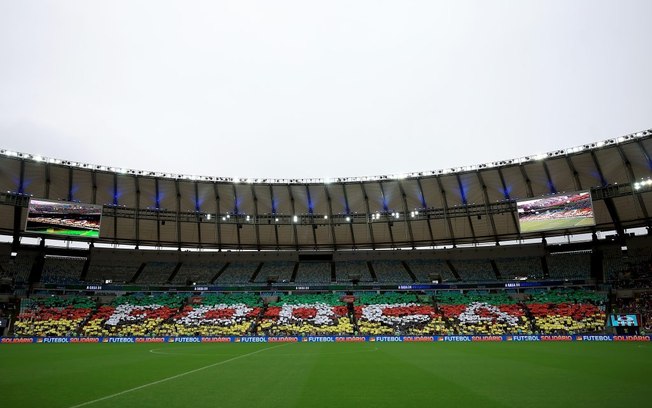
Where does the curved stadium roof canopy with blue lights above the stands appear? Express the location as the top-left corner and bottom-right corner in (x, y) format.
(0, 130), (652, 250)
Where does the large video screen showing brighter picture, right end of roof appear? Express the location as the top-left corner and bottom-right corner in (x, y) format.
(516, 191), (595, 233)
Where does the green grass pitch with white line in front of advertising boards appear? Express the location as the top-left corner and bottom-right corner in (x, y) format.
(0, 342), (652, 408)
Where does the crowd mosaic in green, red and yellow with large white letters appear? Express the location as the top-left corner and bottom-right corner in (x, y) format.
(8, 290), (612, 336)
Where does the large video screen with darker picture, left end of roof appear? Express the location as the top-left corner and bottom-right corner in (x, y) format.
(25, 198), (102, 238)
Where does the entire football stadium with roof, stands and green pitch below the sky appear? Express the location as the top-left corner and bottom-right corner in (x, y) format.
(0, 130), (652, 407)
